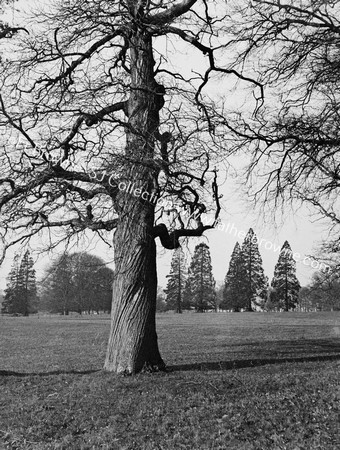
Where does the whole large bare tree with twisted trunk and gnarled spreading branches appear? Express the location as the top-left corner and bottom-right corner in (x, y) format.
(0, 0), (262, 373)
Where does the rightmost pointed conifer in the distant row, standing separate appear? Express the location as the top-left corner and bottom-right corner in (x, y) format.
(271, 241), (301, 311)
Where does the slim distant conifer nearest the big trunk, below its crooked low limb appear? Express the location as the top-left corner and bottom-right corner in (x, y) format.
(165, 248), (189, 313)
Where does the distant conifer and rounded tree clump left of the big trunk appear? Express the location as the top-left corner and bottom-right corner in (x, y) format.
(1, 251), (113, 316)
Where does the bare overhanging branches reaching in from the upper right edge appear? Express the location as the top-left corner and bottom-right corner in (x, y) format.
(222, 0), (340, 227)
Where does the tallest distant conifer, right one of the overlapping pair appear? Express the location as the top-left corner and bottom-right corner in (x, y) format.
(242, 228), (268, 311)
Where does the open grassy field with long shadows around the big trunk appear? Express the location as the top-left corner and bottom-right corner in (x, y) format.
(0, 312), (340, 450)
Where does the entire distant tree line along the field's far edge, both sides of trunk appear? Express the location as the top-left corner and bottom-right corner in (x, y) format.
(0, 229), (340, 316)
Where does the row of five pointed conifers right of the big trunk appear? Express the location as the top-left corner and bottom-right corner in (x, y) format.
(163, 228), (300, 313)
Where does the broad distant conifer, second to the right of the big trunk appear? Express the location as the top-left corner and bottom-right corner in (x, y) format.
(185, 243), (216, 312)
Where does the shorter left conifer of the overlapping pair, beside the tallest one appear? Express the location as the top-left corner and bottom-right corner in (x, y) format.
(220, 242), (247, 312)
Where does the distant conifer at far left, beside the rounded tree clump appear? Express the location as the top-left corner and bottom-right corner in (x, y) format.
(1, 250), (37, 316)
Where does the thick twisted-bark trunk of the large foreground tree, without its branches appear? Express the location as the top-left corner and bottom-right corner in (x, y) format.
(104, 29), (165, 374)
